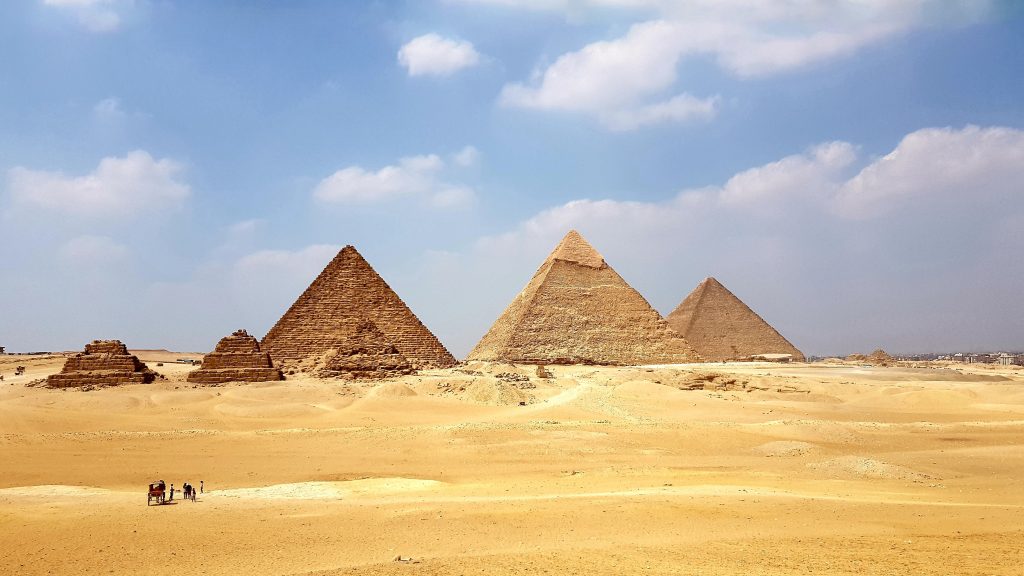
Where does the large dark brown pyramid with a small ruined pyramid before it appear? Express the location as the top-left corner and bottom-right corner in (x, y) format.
(261, 246), (456, 368)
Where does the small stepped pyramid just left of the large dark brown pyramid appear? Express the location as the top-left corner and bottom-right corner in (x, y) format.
(186, 330), (285, 384)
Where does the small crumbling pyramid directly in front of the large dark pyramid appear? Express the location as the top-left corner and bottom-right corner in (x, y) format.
(313, 318), (413, 379)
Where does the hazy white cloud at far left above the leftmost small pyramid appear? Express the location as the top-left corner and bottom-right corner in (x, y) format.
(7, 150), (190, 217)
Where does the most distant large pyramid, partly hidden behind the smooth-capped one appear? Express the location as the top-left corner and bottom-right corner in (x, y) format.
(668, 278), (804, 362)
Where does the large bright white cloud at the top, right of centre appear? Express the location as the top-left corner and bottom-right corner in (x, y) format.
(495, 0), (988, 130)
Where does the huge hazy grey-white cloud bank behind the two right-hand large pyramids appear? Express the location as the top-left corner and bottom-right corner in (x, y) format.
(460, 126), (1024, 354)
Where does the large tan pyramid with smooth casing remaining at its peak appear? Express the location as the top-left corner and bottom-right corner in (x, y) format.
(467, 231), (698, 365)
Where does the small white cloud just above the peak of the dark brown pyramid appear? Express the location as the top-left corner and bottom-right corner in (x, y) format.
(313, 147), (478, 208)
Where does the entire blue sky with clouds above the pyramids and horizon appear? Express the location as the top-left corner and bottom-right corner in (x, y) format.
(0, 0), (1024, 357)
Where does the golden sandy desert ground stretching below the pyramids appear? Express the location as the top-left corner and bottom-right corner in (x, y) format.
(0, 352), (1024, 575)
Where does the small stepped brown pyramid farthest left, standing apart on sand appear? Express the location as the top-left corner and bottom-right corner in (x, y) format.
(46, 340), (157, 388)
